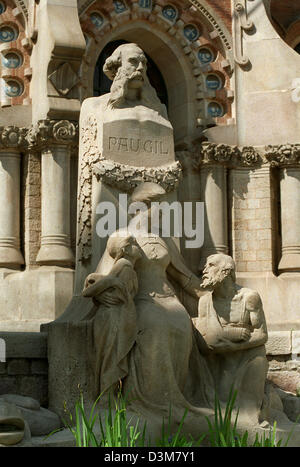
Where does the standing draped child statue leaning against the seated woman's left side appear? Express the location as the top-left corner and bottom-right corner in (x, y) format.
(83, 231), (141, 404)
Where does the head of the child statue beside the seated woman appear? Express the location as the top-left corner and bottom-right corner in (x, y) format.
(107, 231), (140, 261)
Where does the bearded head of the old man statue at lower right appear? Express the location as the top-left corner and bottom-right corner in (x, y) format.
(201, 253), (236, 289)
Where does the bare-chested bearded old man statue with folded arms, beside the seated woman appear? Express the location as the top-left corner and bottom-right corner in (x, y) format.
(195, 254), (268, 424)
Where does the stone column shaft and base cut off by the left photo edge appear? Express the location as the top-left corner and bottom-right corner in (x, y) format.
(0, 148), (24, 269)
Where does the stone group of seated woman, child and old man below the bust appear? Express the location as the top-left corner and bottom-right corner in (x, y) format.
(83, 182), (268, 440)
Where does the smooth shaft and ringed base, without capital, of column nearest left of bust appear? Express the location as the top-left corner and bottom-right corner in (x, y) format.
(36, 145), (74, 266)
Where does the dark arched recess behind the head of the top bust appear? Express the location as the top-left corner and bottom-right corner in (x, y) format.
(94, 40), (168, 108)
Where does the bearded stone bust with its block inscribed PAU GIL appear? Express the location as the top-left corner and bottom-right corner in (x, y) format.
(81, 44), (175, 167)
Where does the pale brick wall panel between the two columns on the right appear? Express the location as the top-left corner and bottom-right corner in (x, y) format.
(229, 168), (278, 272)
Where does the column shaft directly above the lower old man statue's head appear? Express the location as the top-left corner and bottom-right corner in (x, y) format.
(200, 164), (228, 270)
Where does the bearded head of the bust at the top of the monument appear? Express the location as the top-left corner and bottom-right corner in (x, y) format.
(103, 43), (162, 112)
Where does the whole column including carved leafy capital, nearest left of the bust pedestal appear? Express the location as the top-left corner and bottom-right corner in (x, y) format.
(36, 120), (78, 266)
